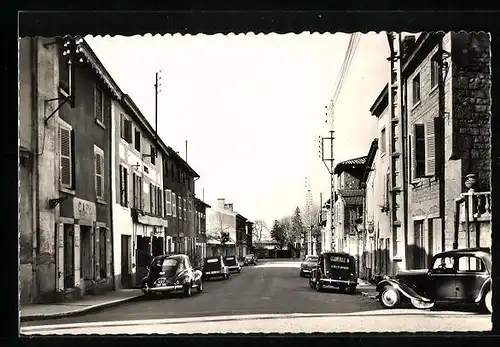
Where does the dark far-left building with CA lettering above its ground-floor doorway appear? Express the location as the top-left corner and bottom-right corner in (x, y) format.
(19, 37), (119, 303)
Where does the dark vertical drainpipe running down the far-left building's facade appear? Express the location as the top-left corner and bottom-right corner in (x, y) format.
(30, 38), (39, 301)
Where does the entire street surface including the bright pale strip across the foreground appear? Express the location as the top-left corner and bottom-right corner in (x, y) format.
(21, 259), (491, 333)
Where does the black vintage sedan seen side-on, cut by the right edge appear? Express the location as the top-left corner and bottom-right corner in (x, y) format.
(377, 248), (492, 313)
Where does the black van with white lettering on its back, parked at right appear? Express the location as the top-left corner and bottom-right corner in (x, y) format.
(309, 252), (358, 294)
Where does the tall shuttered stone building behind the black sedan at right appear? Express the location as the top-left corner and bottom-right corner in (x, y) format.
(360, 33), (491, 274)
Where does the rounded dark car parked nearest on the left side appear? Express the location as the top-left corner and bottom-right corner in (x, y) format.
(142, 254), (203, 297)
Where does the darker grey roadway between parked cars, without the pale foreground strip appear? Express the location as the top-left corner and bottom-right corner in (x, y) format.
(22, 260), (380, 326)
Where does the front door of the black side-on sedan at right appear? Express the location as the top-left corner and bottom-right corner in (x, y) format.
(426, 256), (456, 301)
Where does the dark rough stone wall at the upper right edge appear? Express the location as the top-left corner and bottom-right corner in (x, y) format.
(451, 33), (491, 191)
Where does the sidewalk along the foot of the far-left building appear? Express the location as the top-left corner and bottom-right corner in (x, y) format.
(20, 289), (143, 322)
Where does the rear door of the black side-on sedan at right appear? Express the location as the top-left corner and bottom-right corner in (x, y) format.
(455, 255), (489, 301)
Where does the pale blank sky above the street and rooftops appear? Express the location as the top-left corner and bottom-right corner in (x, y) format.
(85, 32), (389, 227)
